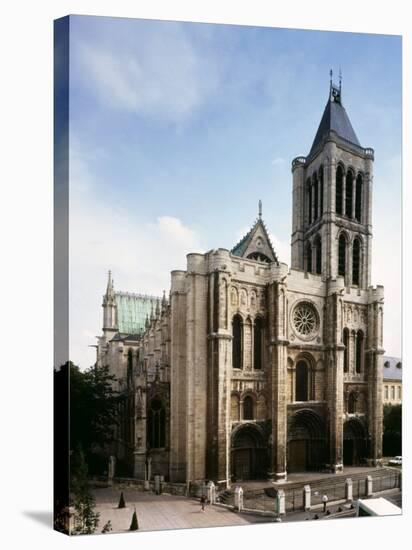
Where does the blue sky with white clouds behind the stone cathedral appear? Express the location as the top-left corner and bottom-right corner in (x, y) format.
(65, 16), (401, 367)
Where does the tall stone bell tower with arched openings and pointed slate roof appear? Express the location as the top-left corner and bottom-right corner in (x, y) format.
(291, 71), (374, 289)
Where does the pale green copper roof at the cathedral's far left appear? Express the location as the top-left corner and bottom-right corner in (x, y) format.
(115, 292), (160, 340)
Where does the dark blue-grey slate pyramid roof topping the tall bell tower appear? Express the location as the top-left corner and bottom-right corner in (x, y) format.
(309, 96), (361, 156)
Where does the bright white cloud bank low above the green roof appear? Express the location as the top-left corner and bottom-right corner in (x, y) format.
(69, 152), (203, 368)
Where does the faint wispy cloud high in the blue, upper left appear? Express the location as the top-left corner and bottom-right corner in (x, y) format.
(71, 25), (219, 122)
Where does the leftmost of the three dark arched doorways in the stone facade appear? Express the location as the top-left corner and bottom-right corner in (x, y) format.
(231, 425), (267, 481)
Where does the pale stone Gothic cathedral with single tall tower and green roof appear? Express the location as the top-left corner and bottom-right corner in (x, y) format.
(96, 77), (384, 487)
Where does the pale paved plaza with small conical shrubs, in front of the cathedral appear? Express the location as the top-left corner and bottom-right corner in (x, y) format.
(94, 488), (272, 533)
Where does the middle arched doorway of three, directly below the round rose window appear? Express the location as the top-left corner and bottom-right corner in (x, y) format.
(287, 409), (326, 473)
